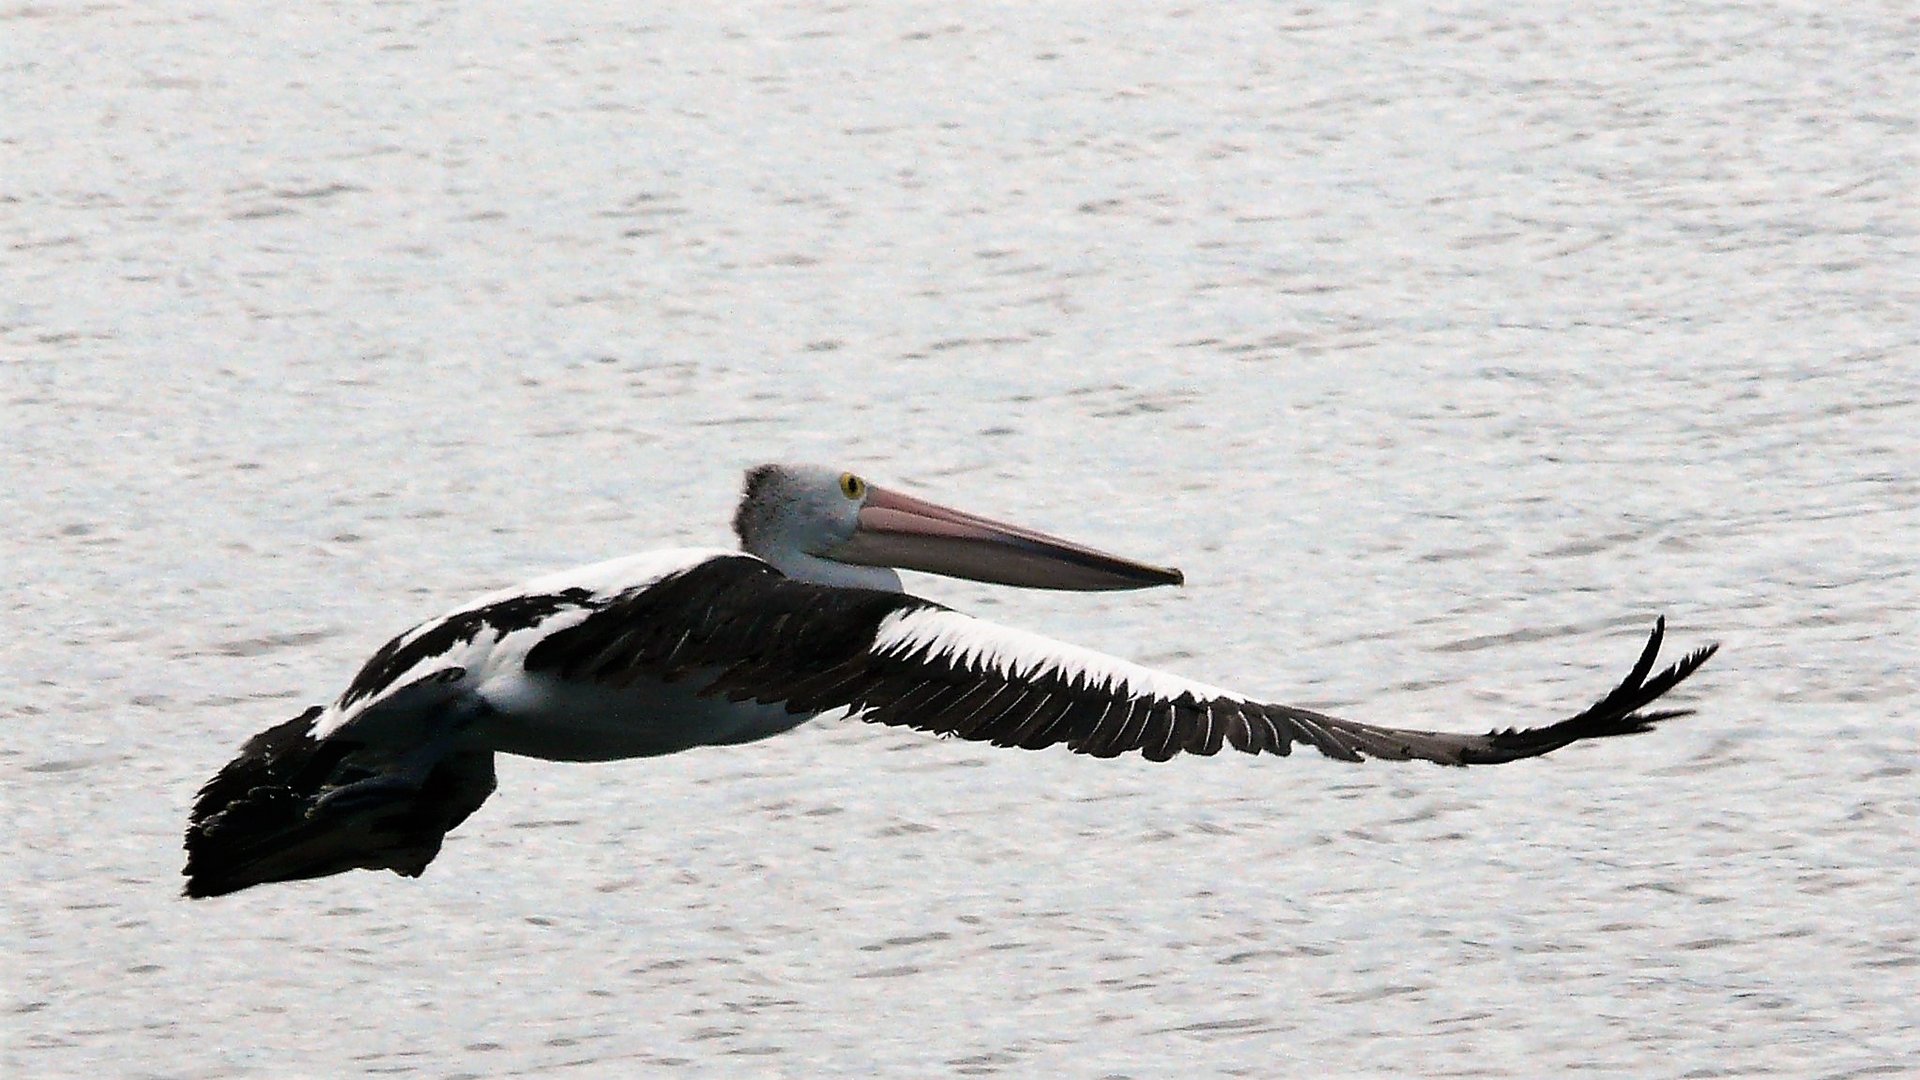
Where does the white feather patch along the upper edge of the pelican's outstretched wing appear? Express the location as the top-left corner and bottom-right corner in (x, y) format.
(874, 609), (1246, 701)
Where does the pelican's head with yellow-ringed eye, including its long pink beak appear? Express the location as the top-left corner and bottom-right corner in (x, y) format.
(733, 465), (1183, 592)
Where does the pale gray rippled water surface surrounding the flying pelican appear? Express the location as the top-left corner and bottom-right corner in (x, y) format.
(0, 0), (1920, 1076)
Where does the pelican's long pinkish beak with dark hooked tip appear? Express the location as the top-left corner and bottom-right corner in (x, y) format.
(828, 484), (1185, 592)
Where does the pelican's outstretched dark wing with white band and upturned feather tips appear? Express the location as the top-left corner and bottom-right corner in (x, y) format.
(526, 557), (1718, 765)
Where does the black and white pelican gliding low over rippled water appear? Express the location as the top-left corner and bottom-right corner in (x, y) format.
(184, 465), (1718, 897)
